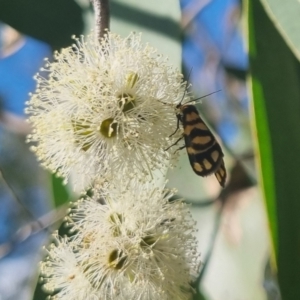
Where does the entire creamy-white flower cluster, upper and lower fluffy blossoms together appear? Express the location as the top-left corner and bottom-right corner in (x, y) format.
(27, 32), (200, 300)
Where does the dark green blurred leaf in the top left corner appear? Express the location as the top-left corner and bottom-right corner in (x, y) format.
(0, 0), (83, 50)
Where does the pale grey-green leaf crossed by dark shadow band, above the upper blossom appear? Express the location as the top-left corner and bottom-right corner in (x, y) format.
(110, 0), (181, 68)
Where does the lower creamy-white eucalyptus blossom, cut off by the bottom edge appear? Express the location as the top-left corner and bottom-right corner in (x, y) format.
(42, 182), (199, 300)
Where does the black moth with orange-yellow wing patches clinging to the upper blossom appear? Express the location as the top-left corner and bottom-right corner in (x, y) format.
(166, 89), (227, 187)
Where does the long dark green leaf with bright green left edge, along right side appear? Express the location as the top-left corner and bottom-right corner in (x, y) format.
(248, 0), (300, 300)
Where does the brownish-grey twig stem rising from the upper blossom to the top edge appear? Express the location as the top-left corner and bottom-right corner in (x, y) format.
(91, 0), (109, 42)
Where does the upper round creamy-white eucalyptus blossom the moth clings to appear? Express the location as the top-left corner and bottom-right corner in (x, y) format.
(27, 32), (188, 188)
